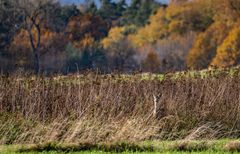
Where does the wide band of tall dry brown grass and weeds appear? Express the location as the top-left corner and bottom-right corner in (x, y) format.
(0, 75), (240, 144)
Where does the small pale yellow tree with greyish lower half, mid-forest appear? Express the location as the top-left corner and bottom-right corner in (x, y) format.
(101, 26), (136, 71)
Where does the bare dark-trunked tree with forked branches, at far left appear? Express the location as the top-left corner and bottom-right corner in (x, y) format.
(9, 0), (59, 74)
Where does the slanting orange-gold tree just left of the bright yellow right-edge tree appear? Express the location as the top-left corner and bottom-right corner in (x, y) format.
(186, 22), (230, 69)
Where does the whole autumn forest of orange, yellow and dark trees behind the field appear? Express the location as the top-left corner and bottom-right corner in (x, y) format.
(0, 0), (240, 74)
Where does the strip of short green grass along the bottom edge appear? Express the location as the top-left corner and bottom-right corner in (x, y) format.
(0, 139), (240, 154)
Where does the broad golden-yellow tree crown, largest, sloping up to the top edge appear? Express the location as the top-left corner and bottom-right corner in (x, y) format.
(129, 0), (213, 46)
